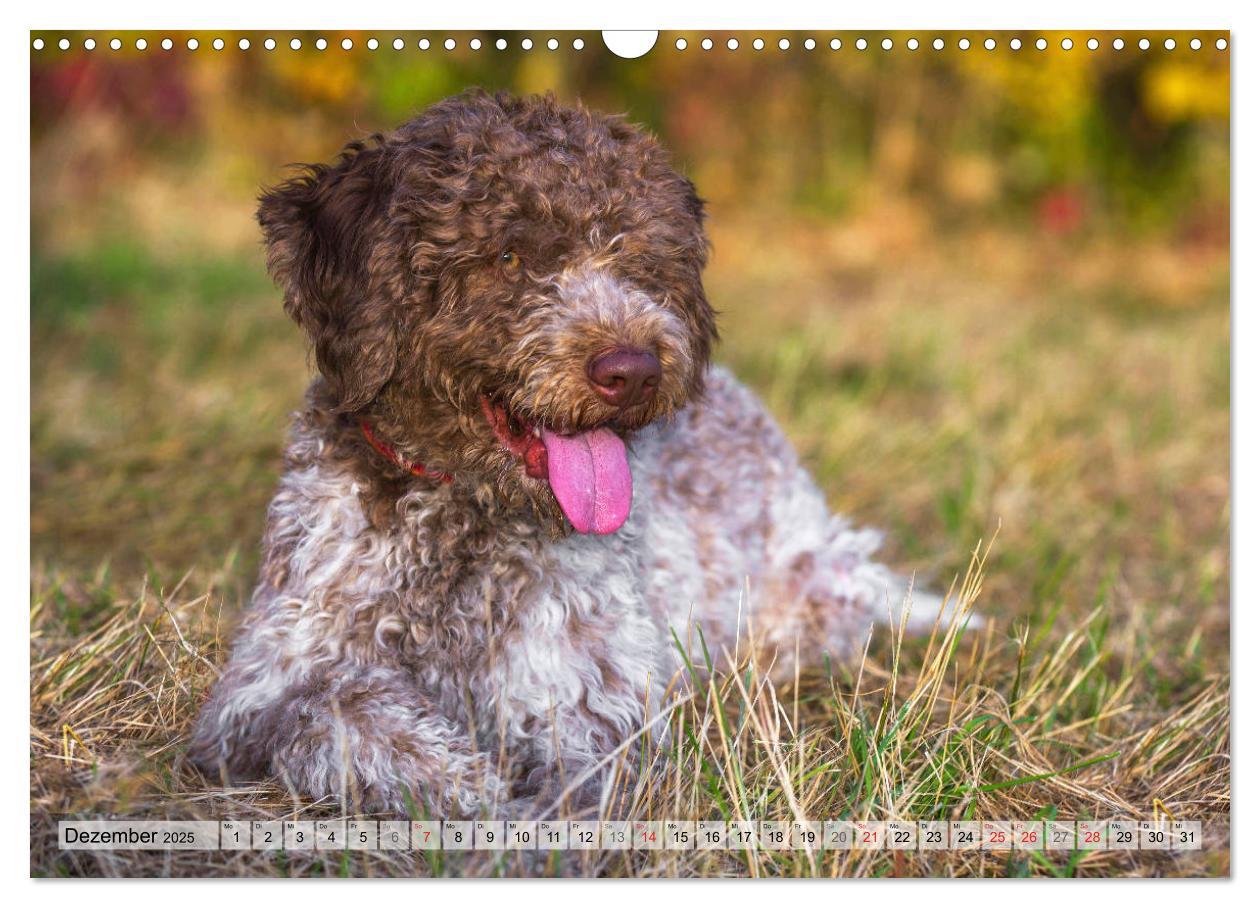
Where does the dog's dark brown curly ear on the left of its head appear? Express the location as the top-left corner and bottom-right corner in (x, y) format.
(258, 140), (398, 412)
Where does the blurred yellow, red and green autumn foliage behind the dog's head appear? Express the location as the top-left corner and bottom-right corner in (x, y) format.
(32, 33), (1230, 258)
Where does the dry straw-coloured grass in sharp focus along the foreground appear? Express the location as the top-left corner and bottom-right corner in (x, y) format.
(32, 541), (1229, 877)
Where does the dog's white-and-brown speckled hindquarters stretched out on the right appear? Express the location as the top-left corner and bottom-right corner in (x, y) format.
(643, 369), (979, 676)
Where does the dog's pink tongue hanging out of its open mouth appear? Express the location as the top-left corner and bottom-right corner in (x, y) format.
(543, 428), (634, 535)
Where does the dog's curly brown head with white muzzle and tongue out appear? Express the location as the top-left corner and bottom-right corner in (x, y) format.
(258, 92), (716, 533)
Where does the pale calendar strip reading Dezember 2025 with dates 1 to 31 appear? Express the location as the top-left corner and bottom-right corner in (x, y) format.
(58, 820), (1203, 851)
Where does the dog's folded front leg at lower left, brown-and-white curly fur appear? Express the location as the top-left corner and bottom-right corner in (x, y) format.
(192, 636), (504, 816)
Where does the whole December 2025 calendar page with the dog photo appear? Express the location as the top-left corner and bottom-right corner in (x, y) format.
(26, 14), (1232, 894)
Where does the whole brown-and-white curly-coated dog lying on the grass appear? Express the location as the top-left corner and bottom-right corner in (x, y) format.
(192, 92), (936, 815)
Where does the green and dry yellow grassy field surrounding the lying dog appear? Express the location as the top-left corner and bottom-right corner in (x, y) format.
(30, 210), (1230, 877)
